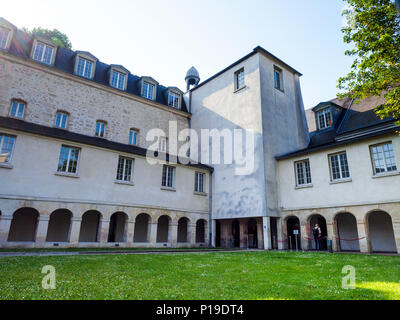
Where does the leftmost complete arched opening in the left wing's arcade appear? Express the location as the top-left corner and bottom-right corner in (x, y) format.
(8, 208), (39, 242)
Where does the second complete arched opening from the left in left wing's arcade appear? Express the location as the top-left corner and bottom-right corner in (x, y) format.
(46, 209), (72, 242)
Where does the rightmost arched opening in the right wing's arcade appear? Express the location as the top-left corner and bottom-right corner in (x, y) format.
(368, 211), (397, 253)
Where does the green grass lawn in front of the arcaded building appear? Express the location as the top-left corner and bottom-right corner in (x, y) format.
(0, 252), (400, 300)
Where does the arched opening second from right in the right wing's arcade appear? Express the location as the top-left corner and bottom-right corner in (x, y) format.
(336, 212), (360, 252)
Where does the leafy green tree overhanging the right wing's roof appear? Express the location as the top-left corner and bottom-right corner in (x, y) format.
(338, 0), (400, 125)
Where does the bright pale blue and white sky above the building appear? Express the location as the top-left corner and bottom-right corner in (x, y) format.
(0, 0), (352, 109)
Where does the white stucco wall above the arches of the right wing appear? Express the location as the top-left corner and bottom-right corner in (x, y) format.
(278, 135), (400, 210)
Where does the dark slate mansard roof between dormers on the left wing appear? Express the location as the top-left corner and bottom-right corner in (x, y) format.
(0, 18), (189, 113)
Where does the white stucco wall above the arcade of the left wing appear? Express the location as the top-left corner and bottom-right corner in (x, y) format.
(0, 128), (209, 213)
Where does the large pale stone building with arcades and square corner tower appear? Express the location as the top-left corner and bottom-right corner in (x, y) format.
(0, 19), (400, 252)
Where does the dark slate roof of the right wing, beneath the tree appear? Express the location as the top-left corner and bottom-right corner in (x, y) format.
(276, 97), (398, 160)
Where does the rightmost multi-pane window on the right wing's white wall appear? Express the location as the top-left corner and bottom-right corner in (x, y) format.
(371, 142), (397, 174)
